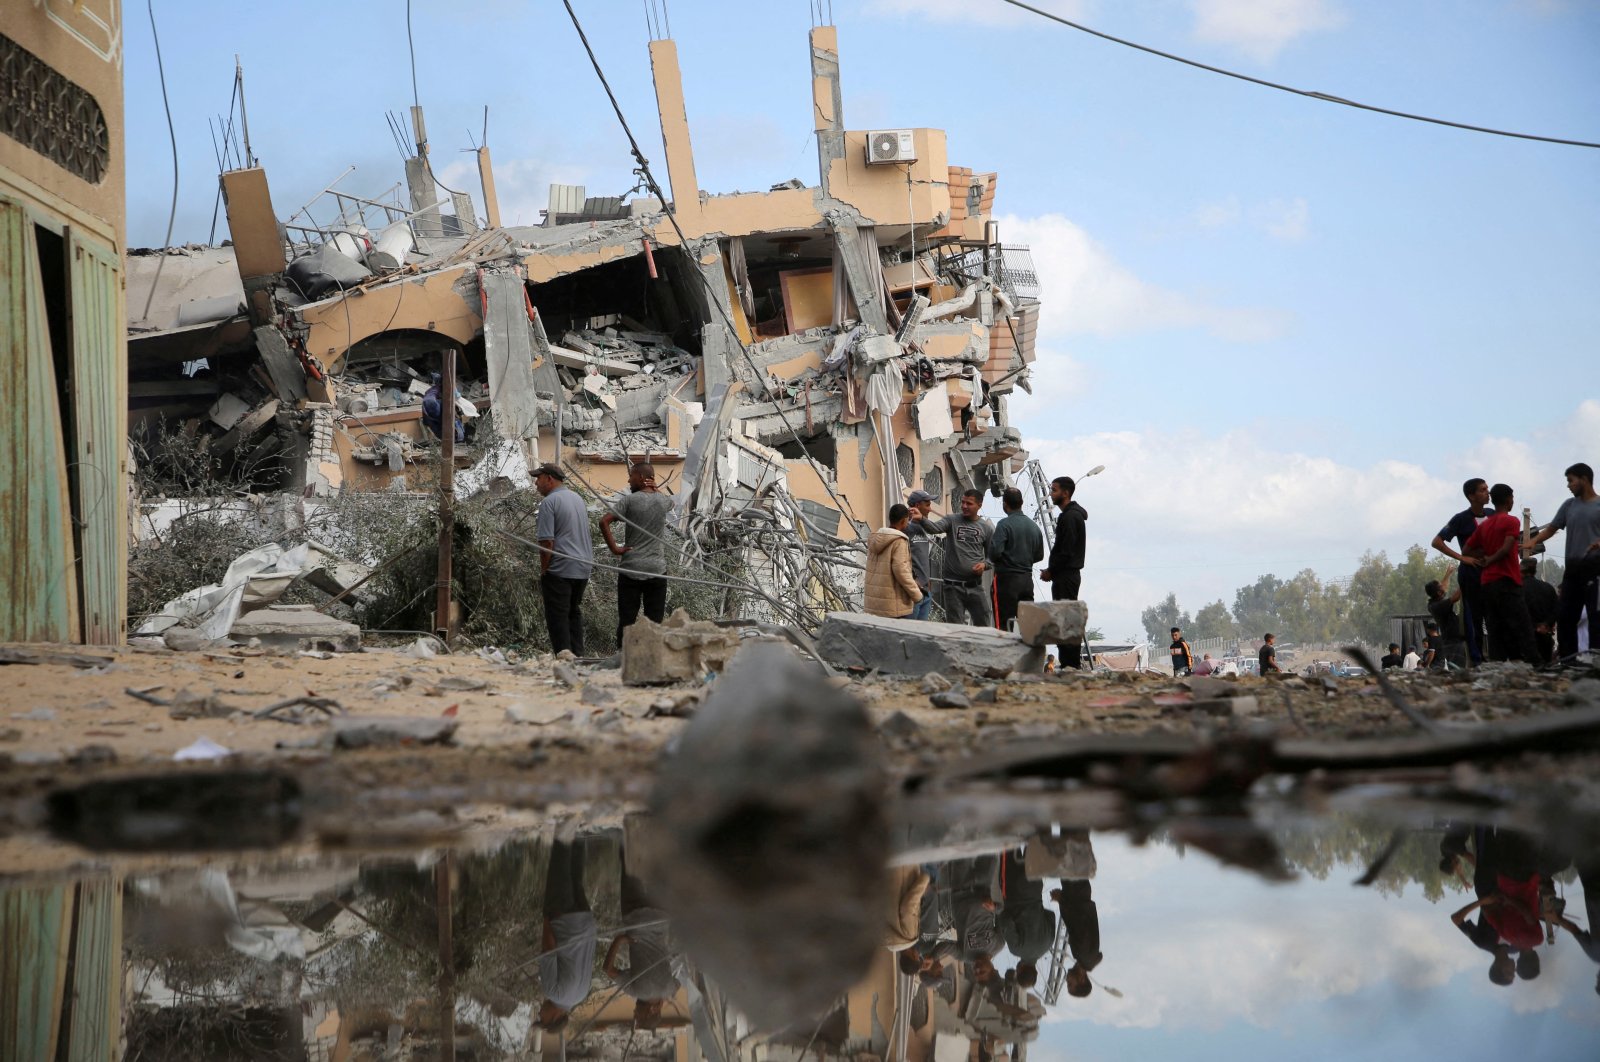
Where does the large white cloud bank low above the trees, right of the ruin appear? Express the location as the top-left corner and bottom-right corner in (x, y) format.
(1010, 396), (1600, 640)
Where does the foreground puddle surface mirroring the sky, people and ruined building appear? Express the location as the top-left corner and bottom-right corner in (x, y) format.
(0, 817), (1600, 1062)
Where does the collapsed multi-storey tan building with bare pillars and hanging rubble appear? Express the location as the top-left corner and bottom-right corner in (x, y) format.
(128, 26), (1038, 630)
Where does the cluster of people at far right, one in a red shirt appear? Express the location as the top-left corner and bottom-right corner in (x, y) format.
(1427, 462), (1600, 665)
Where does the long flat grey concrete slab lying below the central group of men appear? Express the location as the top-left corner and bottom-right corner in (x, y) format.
(816, 613), (1045, 678)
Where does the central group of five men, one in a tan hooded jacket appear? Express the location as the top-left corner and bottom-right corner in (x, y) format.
(866, 475), (1088, 667)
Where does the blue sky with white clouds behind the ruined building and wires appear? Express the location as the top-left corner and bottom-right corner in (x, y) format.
(125, 0), (1600, 638)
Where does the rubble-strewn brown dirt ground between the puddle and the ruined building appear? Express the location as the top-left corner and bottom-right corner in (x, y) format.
(0, 645), (1570, 873)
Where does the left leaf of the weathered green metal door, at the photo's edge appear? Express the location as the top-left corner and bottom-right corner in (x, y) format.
(0, 198), (77, 641)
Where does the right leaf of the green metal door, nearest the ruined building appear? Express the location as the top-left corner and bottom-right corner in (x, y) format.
(67, 232), (128, 645)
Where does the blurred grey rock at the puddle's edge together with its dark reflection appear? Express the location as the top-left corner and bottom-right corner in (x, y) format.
(643, 642), (888, 1028)
